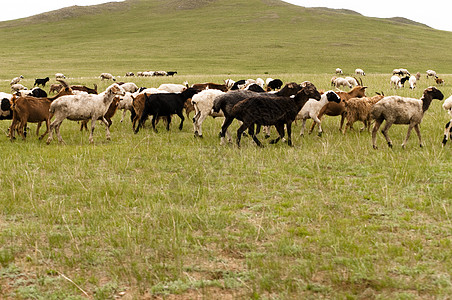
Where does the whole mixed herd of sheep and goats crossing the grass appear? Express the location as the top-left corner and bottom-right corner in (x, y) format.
(0, 69), (452, 149)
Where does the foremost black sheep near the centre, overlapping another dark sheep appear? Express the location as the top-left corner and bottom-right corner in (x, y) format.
(232, 82), (320, 148)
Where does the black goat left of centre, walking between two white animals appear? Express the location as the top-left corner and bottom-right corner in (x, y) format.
(135, 88), (200, 133)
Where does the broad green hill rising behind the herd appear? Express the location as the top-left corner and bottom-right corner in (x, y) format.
(0, 0), (452, 79)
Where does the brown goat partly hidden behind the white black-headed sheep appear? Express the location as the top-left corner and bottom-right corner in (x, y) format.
(309, 85), (367, 133)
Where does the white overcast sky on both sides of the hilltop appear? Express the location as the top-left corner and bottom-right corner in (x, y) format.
(0, 0), (452, 31)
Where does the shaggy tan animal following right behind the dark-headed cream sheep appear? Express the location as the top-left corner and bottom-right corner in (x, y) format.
(342, 93), (384, 134)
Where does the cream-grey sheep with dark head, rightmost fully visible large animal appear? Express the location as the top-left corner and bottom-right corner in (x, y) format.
(371, 86), (444, 149)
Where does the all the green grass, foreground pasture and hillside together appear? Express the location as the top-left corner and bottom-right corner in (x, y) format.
(0, 0), (452, 299)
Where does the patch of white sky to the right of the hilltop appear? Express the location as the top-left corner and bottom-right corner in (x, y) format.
(284, 0), (452, 31)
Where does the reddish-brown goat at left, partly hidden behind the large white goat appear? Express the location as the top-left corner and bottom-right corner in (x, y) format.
(9, 80), (72, 140)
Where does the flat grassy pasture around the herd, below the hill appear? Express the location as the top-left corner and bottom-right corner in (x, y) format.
(0, 73), (452, 299)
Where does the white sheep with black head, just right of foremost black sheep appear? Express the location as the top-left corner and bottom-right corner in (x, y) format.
(296, 91), (341, 136)
